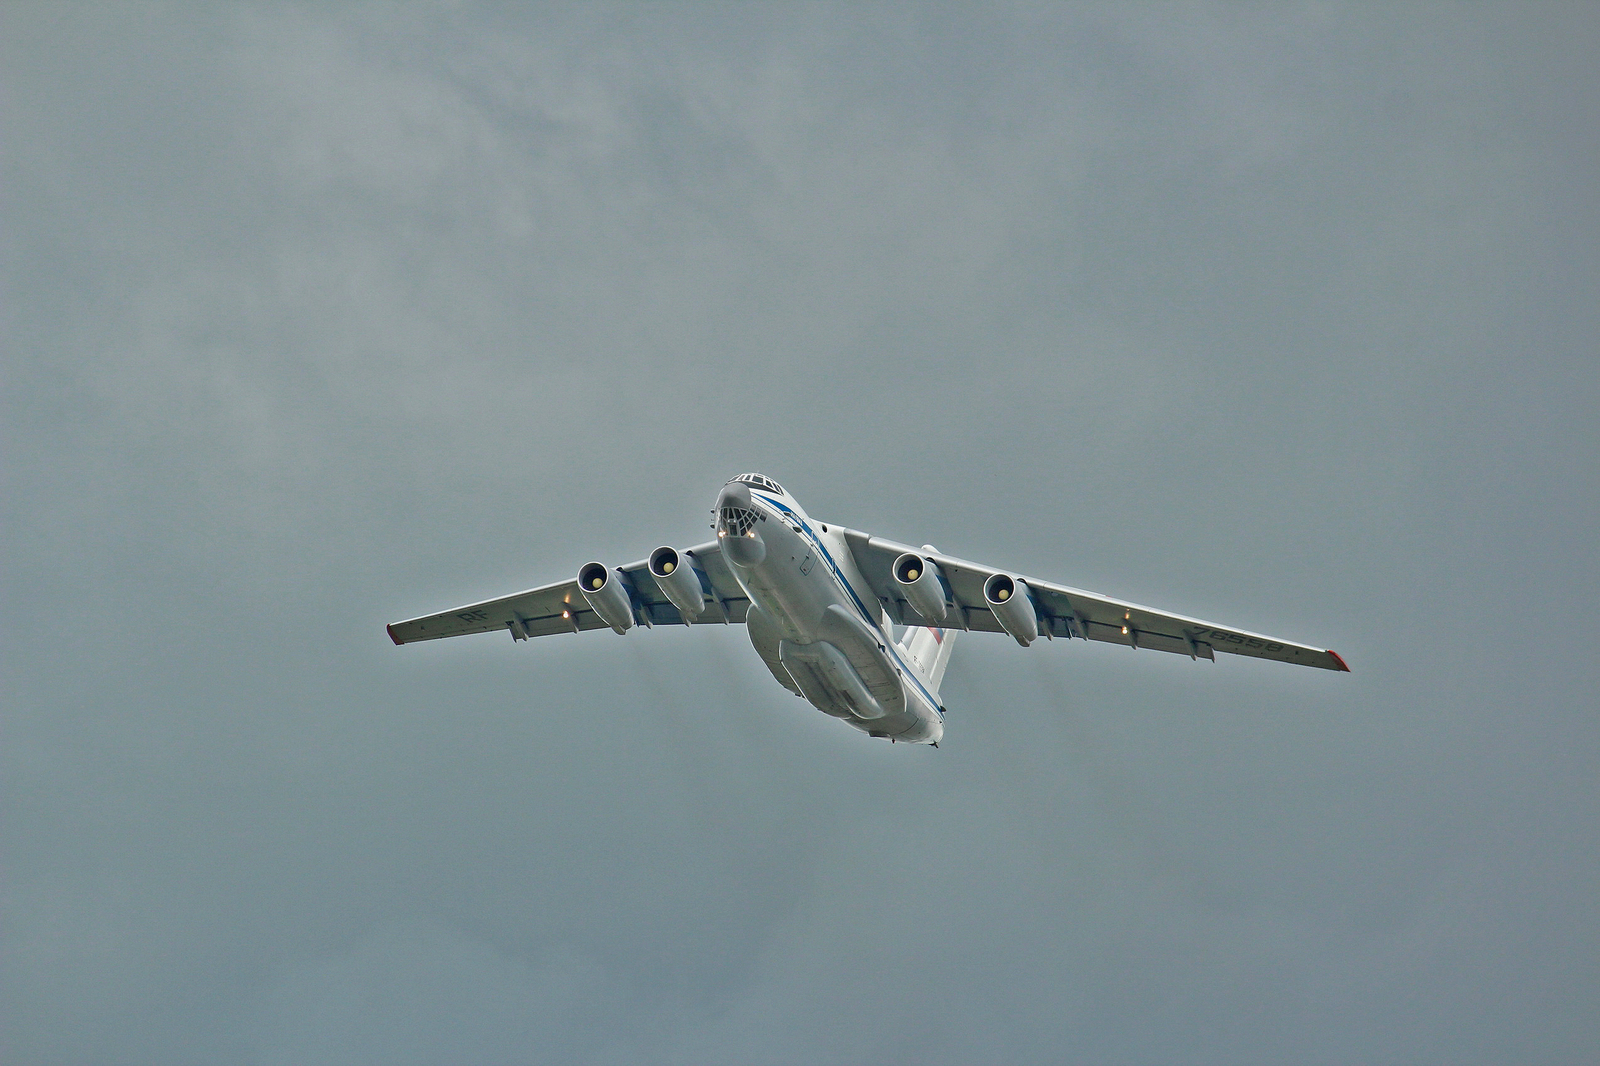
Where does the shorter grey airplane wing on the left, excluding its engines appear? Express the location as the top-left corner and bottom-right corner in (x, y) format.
(389, 541), (750, 643)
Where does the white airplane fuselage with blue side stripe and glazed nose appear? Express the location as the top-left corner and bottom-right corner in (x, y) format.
(717, 482), (944, 744)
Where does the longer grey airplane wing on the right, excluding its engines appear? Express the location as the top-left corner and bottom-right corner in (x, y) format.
(843, 530), (1350, 671)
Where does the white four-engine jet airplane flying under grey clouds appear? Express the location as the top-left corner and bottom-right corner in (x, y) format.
(387, 474), (1350, 747)
